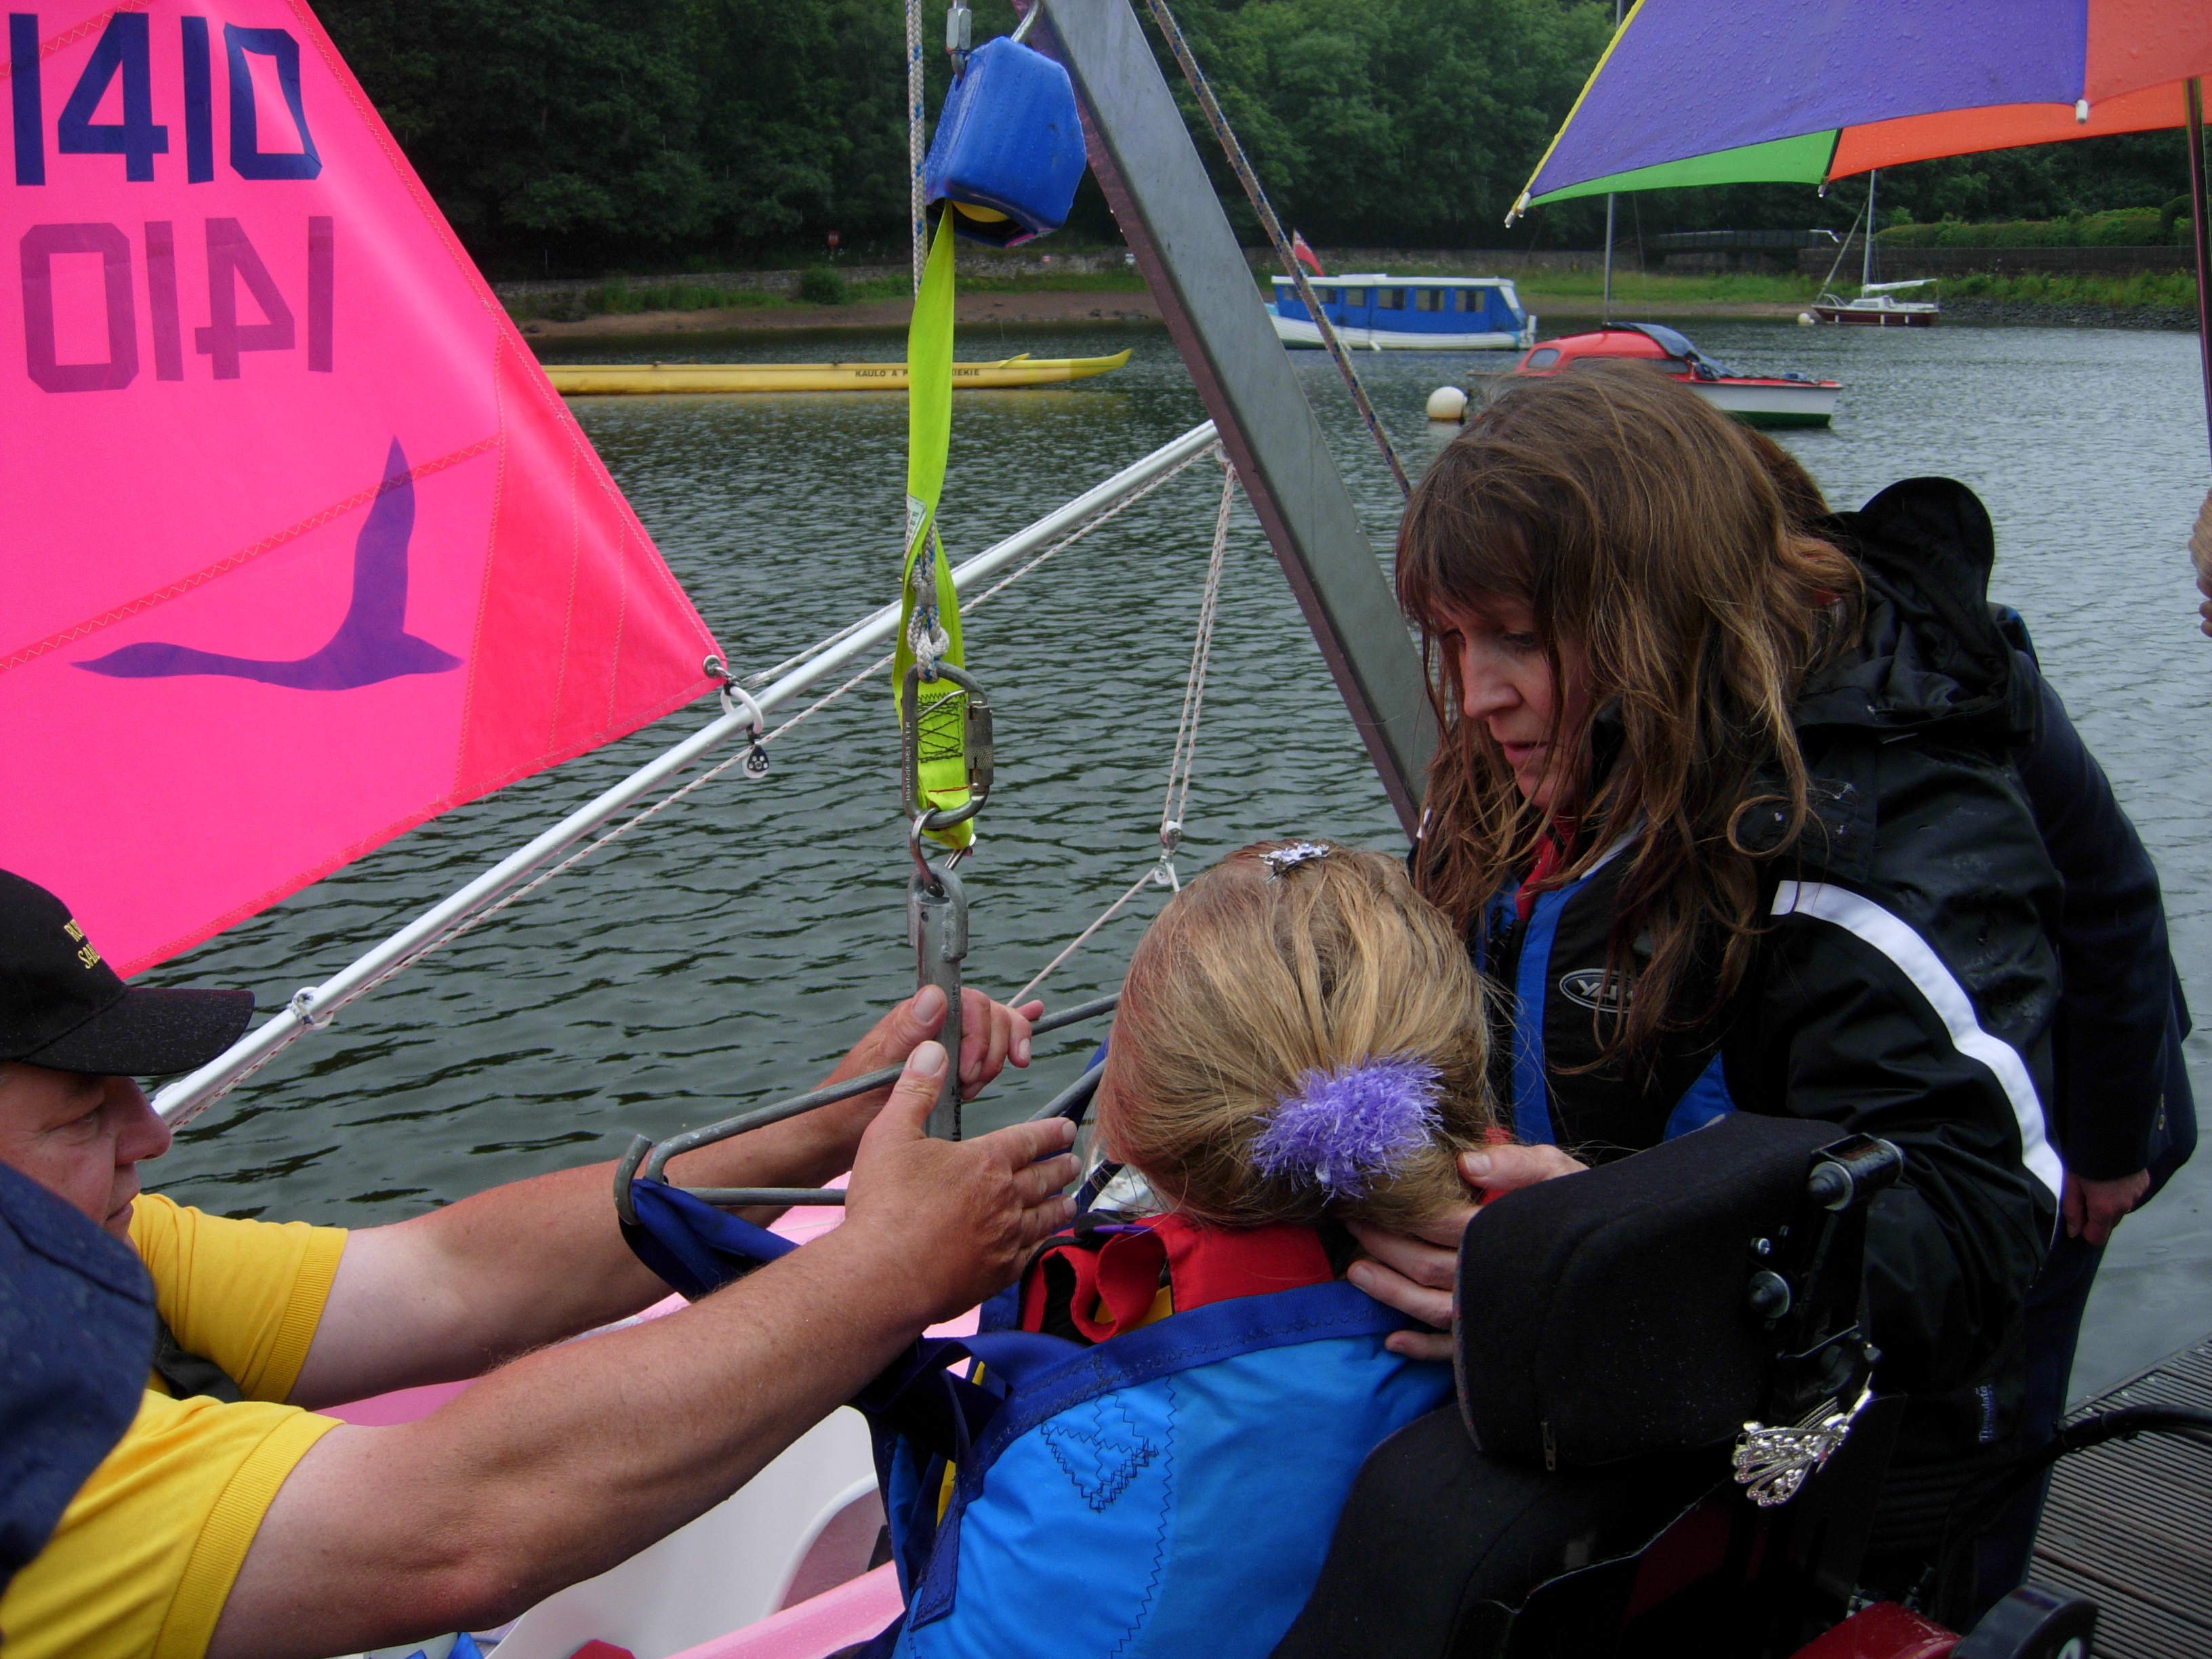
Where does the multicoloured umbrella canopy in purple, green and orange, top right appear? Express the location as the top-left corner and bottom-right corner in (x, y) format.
(1509, 0), (2212, 211)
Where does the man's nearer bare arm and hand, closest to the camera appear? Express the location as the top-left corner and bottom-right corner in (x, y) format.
(208, 1044), (1075, 1659)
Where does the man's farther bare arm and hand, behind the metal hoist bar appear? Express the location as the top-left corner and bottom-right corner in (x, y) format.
(290, 987), (1042, 1409)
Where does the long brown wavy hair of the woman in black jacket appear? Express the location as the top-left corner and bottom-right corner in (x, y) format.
(1398, 363), (1862, 1066)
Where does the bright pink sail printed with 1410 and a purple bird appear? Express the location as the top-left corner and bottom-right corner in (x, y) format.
(0, 0), (717, 973)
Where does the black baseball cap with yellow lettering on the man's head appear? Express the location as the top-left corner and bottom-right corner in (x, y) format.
(0, 869), (254, 1078)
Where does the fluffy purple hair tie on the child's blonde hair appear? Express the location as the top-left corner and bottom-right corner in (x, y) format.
(1252, 1055), (1442, 1199)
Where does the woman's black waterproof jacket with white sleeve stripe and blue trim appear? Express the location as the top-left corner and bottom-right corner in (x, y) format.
(1475, 480), (2064, 1462)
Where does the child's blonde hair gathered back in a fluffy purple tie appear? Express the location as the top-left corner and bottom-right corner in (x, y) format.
(1099, 840), (1493, 1228)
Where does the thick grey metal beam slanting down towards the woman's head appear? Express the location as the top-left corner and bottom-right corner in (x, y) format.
(1029, 0), (1435, 836)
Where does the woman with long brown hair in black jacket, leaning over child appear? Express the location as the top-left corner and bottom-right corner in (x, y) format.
(1356, 363), (2062, 1610)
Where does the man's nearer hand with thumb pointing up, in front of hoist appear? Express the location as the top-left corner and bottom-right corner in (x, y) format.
(838, 1042), (1080, 1323)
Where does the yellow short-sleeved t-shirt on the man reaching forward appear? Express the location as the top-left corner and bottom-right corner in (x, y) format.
(0, 1195), (345, 1659)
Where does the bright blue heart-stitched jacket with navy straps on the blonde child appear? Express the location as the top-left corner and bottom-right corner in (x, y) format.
(633, 1181), (1451, 1659)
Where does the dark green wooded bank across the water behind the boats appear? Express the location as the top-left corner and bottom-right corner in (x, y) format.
(319, 0), (2188, 276)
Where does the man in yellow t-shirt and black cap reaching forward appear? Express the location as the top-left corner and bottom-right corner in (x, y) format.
(0, 872), (1075, 1659)
